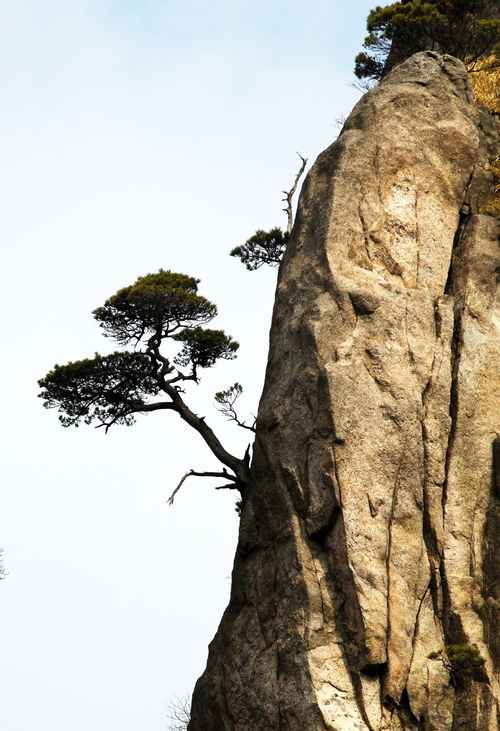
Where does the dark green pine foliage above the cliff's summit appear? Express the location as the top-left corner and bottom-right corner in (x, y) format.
(354, 0), (500, 80)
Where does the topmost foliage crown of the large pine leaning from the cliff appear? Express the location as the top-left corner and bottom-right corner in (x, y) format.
(93, 269), (217, 345)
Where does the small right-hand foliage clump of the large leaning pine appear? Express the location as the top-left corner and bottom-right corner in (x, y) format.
(172, 327), (240, 368)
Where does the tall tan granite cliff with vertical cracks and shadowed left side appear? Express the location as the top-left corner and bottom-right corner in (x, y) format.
(189, 52), (500, 731)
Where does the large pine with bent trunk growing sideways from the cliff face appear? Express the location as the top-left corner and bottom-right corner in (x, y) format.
(39, 269), (249, 498)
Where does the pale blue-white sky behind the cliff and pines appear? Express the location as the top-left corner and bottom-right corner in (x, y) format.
(0, 0), (373, 731)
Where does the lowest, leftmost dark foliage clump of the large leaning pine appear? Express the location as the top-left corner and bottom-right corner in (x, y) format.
(38, 352), (159, 426)
